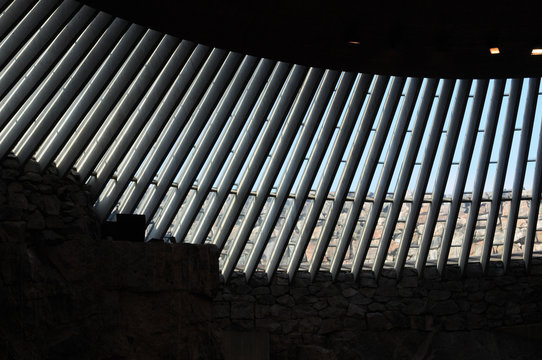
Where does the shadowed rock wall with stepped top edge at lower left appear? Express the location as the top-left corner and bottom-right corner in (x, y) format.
(0, 157), (221, 359)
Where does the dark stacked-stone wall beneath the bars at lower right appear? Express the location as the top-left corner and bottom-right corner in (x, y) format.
(214, 261), (542, 359)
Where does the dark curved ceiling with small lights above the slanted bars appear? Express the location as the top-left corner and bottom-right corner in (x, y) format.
(78, 0), (542, 78)
